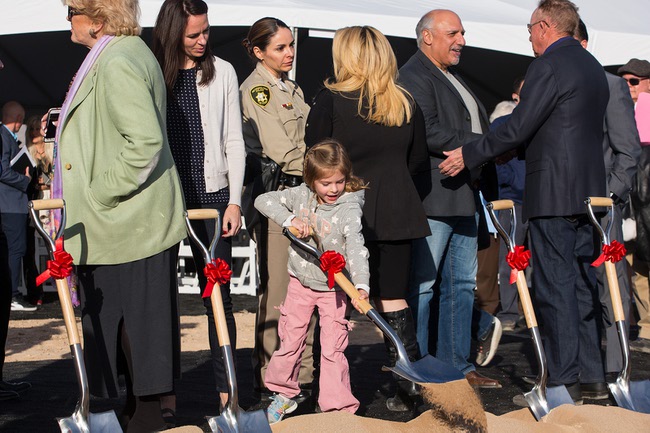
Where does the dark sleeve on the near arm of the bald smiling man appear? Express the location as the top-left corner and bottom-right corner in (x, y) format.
(400, 74), (481, 158)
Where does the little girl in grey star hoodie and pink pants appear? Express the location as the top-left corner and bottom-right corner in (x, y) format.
(255, 140), (370, 424)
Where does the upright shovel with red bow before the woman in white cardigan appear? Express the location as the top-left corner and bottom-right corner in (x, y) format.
(185, 209), (271, 433)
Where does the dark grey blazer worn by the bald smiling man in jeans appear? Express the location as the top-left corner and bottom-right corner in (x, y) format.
(399, 50), (488, 216)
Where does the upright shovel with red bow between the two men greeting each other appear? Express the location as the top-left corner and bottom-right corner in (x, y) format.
(485, 200), (574, 421)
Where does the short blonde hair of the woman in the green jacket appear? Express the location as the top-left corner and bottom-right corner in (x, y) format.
(61, 0), (142, 36)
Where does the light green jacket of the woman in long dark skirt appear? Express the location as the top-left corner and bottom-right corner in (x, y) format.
(59, 36), (186, 265)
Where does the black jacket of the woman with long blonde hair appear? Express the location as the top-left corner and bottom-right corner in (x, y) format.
(305, 89), (430, 241)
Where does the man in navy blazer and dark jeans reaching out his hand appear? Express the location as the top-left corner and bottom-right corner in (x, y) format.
(439, 0), (609, 401)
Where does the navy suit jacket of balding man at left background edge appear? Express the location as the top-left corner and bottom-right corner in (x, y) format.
(0, 123), (30, 214)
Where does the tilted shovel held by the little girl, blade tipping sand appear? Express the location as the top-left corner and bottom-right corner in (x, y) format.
(283, 227), (465, 384)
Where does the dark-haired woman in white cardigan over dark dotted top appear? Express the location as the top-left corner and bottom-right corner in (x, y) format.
(153, 0), (245, 424)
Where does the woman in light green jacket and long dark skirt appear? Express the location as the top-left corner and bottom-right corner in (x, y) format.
(52, 0), (186, 433)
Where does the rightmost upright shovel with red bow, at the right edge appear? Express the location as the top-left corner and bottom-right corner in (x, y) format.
(585, 197), (650, 413)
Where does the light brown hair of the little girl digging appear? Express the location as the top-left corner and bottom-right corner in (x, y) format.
(302, 138), (368, 192)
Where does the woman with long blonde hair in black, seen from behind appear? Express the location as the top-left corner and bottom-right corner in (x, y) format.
(305, 26), (430, 411)
